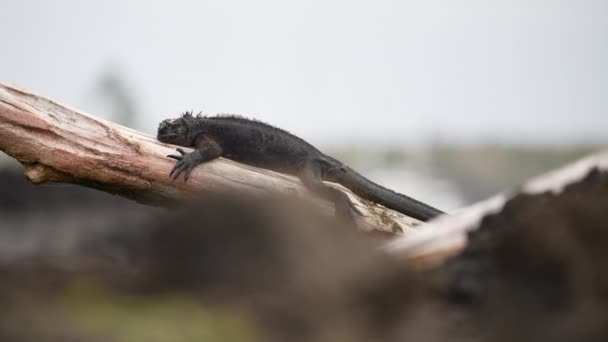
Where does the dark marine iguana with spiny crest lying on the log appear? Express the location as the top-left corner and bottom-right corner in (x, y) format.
(157, 112), (443, 221)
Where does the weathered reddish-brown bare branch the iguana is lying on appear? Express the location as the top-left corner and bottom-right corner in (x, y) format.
(0, 83), (420, 233)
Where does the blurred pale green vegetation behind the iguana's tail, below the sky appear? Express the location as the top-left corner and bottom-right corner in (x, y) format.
(327, 143), (603, 203)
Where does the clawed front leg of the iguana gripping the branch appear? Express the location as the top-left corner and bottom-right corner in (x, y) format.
(167, 139), (222, 182)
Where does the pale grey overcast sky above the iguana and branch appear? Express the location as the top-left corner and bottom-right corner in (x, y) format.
(0, 0), (608, 144)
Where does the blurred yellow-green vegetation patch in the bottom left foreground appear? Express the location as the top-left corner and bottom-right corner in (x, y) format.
(2, 278), (254, 342)
